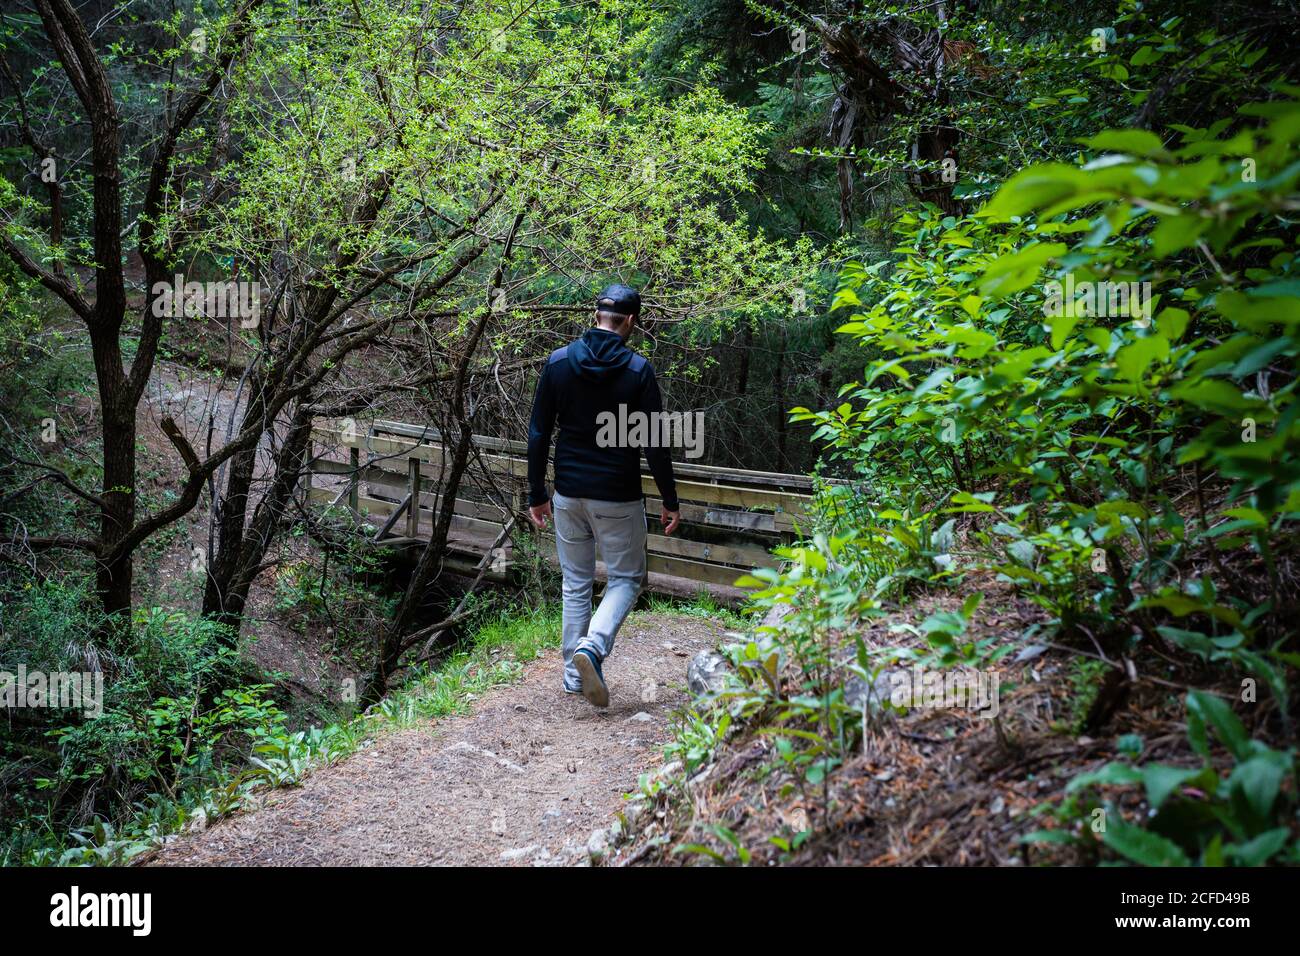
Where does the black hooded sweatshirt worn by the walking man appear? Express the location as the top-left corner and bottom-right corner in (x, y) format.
(528, 329), (677, 511)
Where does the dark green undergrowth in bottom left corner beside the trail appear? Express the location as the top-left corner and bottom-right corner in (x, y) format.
(0, 578), (257, 855)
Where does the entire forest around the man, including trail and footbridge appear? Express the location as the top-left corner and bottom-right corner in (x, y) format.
(0, 0), (1300, 884)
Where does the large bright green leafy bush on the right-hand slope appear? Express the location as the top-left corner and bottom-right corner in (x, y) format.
(796, 85), (1300, 655)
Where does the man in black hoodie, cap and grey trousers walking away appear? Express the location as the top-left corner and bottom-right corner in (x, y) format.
(528, 285), (681, 708)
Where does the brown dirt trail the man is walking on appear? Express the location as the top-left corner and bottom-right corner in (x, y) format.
(150, 613), (720, 866)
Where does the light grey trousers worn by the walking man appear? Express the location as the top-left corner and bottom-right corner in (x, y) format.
(551, 492), (646, 691)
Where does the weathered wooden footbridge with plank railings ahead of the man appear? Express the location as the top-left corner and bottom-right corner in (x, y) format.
(306, 420), (813, 600)
